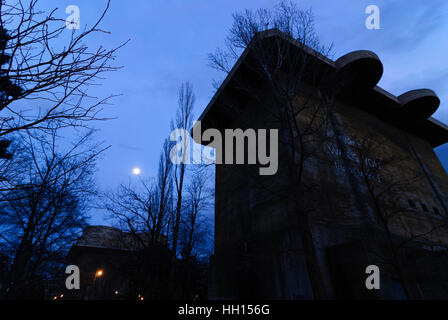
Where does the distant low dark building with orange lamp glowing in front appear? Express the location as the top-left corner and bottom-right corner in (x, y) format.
(67, 226), (171, 300)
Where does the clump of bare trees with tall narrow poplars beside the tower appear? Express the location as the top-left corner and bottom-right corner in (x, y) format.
(102, 82), (213, 299)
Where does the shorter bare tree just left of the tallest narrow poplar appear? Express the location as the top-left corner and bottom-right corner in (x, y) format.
(101, 140), (174, 299)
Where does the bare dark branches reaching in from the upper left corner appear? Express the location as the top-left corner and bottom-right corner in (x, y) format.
(0, 0), (125, 137)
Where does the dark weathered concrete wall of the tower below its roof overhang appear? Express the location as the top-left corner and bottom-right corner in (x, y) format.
(214, 83), (448, 299)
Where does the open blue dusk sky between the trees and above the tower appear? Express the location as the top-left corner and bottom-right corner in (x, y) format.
(36, 0), (448, 223)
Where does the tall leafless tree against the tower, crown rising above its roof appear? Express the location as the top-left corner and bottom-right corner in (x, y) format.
(210, 1), (335, 299)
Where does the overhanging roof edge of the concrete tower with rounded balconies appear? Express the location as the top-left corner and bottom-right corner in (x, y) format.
(193, 29), (448, 148)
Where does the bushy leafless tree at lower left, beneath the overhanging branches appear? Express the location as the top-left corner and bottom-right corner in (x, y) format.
(0, 131), (105, 298)
